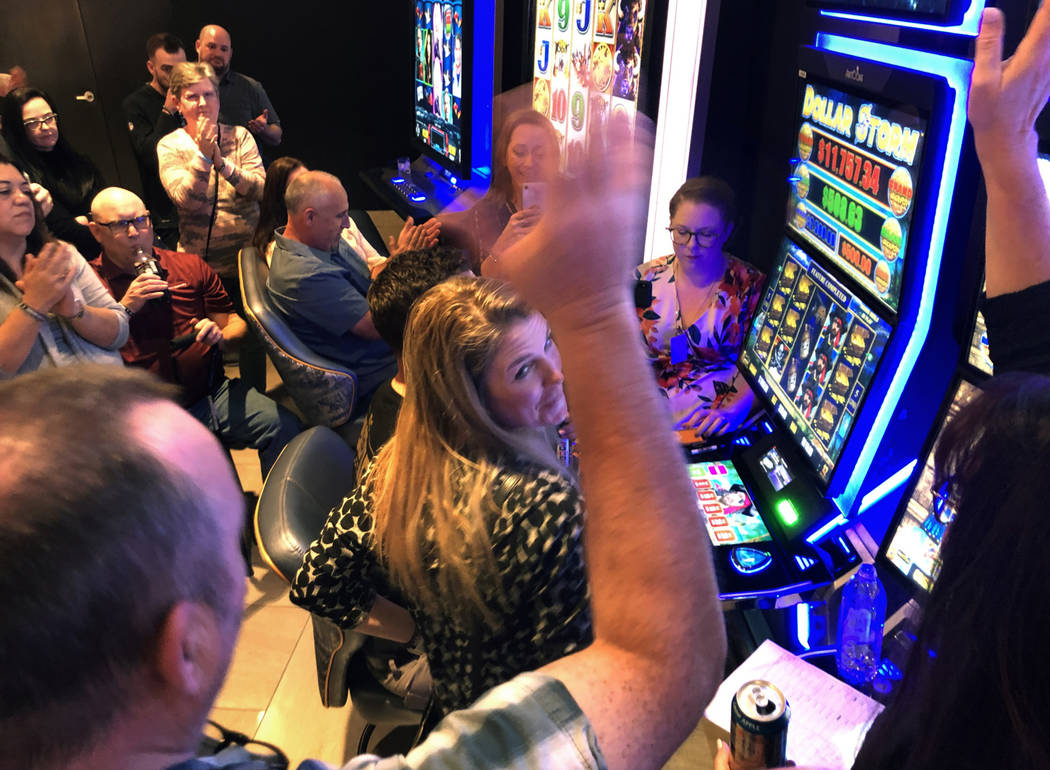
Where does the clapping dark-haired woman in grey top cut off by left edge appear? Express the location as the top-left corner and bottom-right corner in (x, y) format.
(0, 155), (128, 377)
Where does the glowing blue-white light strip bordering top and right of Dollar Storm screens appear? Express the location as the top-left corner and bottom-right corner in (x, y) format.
(806, 33), (973, 516)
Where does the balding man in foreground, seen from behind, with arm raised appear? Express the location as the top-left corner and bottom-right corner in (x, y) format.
(0, 122), (726, 770)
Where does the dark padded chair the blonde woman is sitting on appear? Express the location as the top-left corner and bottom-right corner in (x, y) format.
(255, 425), (423, 753)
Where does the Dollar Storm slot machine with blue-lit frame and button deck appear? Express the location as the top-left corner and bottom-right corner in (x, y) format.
(690, 0), (984, 600)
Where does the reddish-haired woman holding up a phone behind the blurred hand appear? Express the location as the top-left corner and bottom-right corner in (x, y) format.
(438, 109), (561, 276)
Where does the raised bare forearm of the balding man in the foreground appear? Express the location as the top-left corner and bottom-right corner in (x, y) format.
(549, 298), (726, 753)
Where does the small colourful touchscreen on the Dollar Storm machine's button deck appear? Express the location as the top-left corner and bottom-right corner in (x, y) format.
(689, 455), (772, 545)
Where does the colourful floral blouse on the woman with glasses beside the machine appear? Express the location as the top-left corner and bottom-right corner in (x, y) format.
(634, 254), (765, 428)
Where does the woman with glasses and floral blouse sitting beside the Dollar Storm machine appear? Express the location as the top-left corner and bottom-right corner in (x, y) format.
(634, 176), (764, 443)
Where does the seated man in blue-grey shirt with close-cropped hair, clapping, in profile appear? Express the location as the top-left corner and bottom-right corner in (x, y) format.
(267, 171), (397, 411)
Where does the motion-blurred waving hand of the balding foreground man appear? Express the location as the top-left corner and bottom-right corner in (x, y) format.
(499, 121), (652, 326)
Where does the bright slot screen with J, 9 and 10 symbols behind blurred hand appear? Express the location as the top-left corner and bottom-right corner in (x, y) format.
(532, 0), (646, 168)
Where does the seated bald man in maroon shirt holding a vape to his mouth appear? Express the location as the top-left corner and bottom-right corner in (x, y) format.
(89, 187), (302, 479)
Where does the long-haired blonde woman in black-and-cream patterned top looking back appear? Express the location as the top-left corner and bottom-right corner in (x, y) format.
(292, 277), (592, 711)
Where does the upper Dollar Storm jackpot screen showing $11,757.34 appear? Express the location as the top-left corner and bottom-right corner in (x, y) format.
(788, 71), (926, 312)
